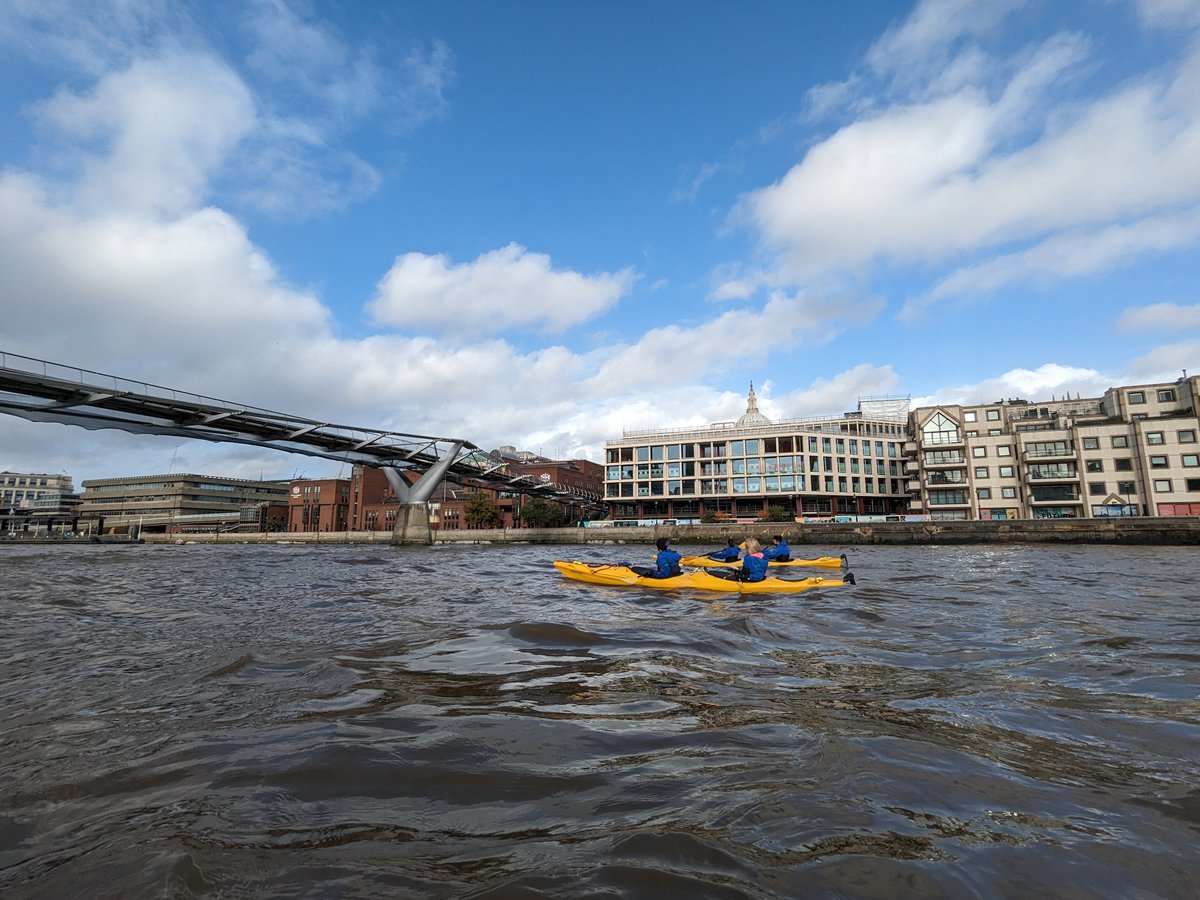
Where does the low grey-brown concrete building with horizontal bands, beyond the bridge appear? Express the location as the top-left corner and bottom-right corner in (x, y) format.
(79, 474), (288, 534)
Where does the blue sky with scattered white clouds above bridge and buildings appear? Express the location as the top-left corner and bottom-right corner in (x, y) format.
(0, 0), (1200, 487)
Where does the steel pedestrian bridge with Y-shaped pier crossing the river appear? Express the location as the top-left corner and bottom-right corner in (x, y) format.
(0, 352), (605, 544)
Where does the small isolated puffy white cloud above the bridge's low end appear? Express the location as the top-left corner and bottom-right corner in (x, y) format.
(368, 244), (635, 334)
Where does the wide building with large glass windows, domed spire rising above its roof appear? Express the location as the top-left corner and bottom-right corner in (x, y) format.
(604, 385), (908, 523)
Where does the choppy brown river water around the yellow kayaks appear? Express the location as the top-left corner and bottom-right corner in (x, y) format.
(0, 545), (1200, 900)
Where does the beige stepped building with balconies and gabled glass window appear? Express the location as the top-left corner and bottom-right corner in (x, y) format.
(904, 373), (1200, 520)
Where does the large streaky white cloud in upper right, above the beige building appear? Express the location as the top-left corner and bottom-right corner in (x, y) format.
(730, 10), (1200, 317)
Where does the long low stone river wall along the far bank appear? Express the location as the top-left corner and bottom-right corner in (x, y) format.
(129, 517), (1200, 547)
